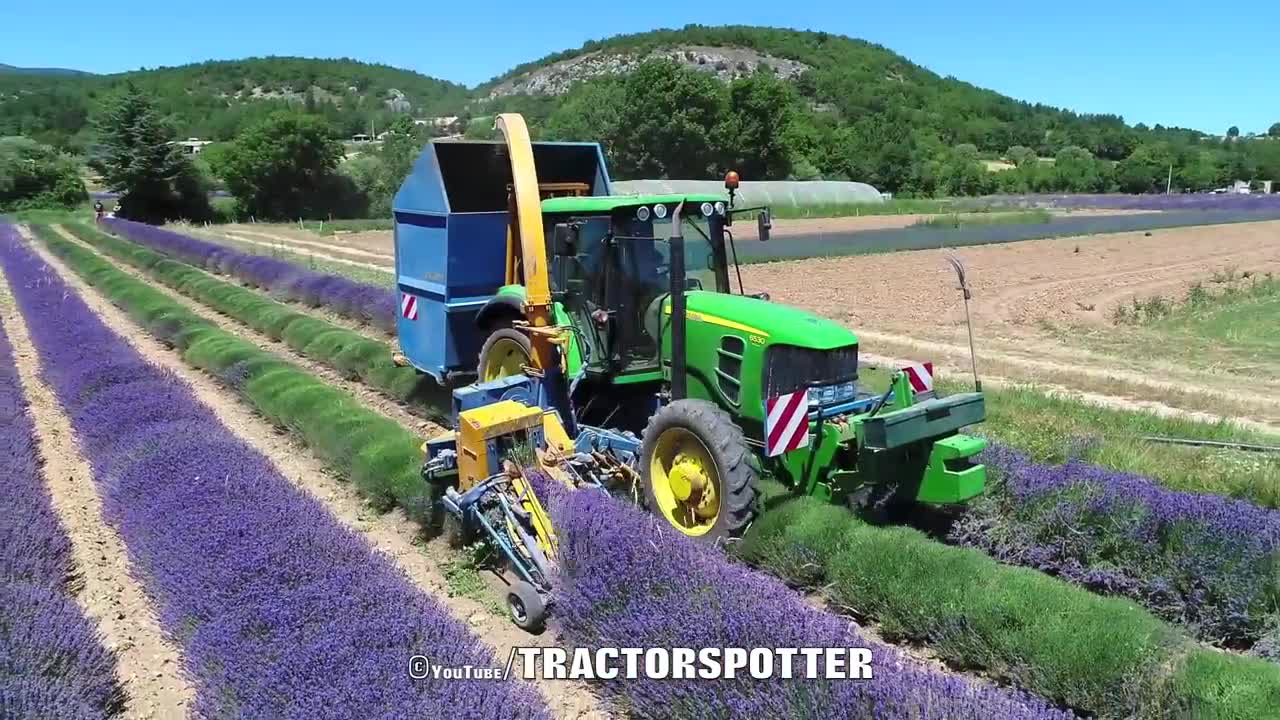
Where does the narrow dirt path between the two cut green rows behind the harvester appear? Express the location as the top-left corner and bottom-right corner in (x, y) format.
(54, 225), (443, 437)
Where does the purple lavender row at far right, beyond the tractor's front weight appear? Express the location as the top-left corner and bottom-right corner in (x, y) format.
(952, 447), (1280, 647)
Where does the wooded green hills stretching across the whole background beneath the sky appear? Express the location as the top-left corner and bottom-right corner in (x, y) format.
(0, 26), (1280, 195)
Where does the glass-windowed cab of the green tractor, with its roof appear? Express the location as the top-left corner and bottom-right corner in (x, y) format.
(541, 195), (730, 378)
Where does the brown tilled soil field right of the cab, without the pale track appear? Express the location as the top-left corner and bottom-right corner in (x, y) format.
(742, 222), (1280, 332)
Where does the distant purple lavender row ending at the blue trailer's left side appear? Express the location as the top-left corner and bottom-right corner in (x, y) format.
(104, 218), (396, 332)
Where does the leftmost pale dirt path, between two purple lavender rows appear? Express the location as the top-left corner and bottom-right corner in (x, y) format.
(0, 256), (195, 720)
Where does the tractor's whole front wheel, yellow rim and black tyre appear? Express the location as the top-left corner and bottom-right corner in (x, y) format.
(640, 400), (759, 543)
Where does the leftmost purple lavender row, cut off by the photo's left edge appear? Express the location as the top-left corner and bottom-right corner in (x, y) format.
(0, 224), (124, 717)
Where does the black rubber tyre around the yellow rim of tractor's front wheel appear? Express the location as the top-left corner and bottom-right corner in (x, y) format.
(640, 400), (760, 543)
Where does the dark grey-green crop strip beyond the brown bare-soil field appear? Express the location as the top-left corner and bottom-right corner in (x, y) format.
(735, 208), (1280, 261)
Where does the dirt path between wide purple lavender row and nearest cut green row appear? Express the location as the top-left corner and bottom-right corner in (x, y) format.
(24, 229), (608, 720)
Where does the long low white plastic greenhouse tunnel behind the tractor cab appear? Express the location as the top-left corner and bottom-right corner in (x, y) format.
(612, 181), (884, 208)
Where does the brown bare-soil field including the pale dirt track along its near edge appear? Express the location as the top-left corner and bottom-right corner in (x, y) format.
(742, 222), (1280, 423)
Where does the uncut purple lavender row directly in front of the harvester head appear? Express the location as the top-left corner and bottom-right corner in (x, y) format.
(535, 478), (1071, 720)
